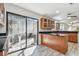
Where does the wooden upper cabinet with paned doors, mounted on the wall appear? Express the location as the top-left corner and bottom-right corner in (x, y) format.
(40, 18), (55, 30)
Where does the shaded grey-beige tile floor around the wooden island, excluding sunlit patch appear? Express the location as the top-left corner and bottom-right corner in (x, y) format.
(31, 42), (79, 56)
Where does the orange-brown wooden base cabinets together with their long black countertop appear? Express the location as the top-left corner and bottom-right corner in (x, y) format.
(39, 31), (78, 54)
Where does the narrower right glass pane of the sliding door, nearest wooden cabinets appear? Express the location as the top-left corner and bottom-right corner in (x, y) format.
(27, 17), (37, 47)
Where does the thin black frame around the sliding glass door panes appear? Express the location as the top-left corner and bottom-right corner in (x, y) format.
(6, 11), (39, 54)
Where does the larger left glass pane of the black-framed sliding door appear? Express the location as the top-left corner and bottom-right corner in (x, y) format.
(8, 13), (26, 52)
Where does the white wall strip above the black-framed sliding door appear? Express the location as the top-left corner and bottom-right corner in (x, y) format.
(5, 3), (40, 19)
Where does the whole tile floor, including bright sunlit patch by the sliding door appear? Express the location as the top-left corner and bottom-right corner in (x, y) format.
(8, 42), (79, 56)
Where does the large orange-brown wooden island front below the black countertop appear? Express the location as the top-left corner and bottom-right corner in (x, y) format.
(41, 34), (68, 54)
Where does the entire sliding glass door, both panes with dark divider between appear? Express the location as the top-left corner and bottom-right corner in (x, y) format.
(7, 12), (38, 52)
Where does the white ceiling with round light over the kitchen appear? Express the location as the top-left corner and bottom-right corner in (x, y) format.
(14, 3), (79, 22)
